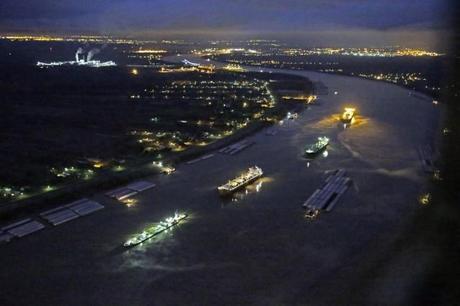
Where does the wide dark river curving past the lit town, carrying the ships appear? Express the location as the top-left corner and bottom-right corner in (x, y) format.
(0, 57), (440, 306)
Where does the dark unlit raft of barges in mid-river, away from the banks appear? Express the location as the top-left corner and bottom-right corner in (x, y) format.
(303, 169), (351, 216)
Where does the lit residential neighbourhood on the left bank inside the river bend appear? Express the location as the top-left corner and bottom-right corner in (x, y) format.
(126, 78), (276, 153)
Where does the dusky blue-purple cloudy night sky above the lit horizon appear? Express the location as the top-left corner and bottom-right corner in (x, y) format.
(0, 0), (447, 47)
